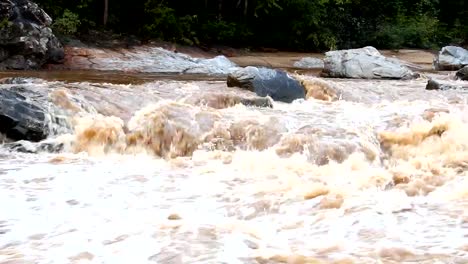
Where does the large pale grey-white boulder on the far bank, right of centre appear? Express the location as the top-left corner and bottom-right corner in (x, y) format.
(322, 47), (417, 79)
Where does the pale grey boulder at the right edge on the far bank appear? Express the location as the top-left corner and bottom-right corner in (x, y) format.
(434, 46), (468, 71)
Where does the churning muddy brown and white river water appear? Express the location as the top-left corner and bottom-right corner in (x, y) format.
(0, 69), (468, 264)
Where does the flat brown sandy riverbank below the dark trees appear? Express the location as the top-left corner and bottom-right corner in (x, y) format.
(38, 36), (437, 75)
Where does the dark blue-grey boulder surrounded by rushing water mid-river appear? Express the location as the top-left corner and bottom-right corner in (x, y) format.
(227, 66), (305, 103)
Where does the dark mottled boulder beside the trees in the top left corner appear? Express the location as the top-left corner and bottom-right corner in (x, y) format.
(0, 0), (64, 69)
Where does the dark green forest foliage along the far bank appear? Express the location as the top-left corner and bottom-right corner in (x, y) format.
(33, 0), (468, 51)
